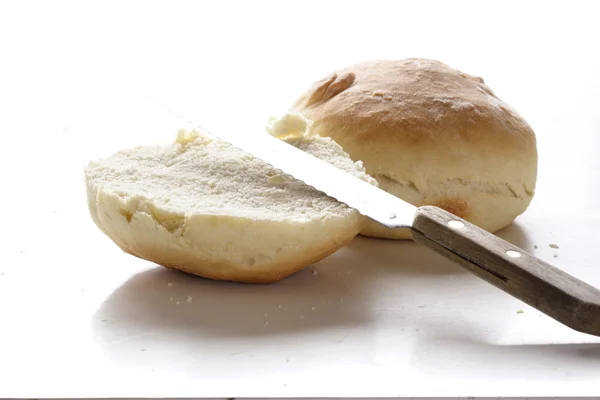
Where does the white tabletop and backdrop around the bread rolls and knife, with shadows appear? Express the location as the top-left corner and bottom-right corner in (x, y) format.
(0, 1), (600, 397)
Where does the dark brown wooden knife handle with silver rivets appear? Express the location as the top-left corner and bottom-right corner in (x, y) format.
(413, 206), (600, 336)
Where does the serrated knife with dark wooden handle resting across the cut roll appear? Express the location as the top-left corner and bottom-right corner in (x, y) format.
(154, 100), (600, 336)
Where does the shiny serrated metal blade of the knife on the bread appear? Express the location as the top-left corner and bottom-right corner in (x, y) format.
(154, 100), (417, 228)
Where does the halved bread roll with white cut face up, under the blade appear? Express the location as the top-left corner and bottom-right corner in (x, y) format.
(85, 119), (376, 283)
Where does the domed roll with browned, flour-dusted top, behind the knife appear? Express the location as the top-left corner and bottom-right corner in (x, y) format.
(291, 59), (538, 239)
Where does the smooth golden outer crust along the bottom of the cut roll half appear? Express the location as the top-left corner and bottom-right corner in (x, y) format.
(88, 185), (361, 284)
